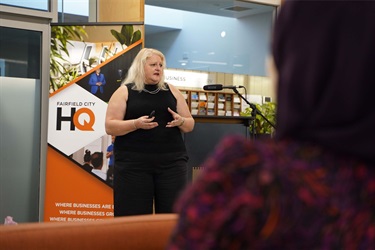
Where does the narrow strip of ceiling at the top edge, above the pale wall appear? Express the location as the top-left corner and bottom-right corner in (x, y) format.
(145, 0), (274, 18)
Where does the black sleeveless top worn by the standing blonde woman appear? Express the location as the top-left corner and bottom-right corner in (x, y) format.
(114, 83), (186, 153)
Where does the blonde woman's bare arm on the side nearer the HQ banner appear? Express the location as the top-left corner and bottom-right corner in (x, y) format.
(105, 85), (138, 136)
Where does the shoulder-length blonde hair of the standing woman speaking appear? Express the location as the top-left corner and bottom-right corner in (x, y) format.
(122, 48), (167, 91)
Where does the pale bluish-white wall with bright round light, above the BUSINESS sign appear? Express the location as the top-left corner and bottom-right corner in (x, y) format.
(145, 5), (273, 76)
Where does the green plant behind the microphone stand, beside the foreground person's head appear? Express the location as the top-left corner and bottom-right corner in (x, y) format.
(241, 102), (276, 134)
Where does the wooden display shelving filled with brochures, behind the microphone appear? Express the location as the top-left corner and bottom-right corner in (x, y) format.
(180, 89), (242, 116)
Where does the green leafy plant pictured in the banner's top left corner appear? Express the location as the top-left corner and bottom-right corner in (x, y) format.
(50, 26), (87, 92)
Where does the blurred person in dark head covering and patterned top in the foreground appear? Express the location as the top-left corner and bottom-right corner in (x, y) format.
(167, 0), (375, 250)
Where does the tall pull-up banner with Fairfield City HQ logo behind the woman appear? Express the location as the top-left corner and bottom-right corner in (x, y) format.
(44, 25), (143, 222)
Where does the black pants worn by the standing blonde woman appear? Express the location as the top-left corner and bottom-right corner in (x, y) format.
(113, 151), (188, 217)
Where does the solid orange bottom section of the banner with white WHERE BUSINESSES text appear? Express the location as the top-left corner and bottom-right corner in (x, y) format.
(44, 147), (113, 222)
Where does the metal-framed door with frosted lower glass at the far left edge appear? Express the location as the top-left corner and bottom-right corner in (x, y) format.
(0, 13), (50, 223)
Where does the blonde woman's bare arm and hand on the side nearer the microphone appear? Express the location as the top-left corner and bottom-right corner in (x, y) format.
(167, 83), (195, 133)
